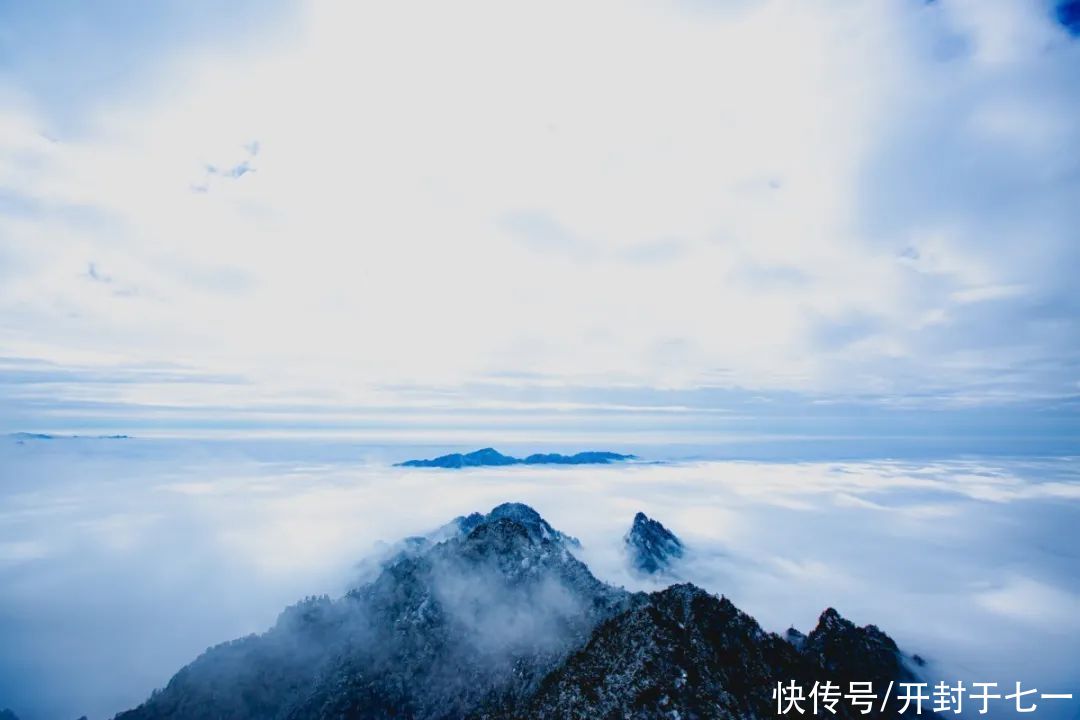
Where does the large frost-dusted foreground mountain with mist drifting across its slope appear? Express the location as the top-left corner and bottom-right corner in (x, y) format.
(117, 503), (934, 720)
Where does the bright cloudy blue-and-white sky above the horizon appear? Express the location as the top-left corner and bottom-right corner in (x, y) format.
(0, 0), (1080, 441)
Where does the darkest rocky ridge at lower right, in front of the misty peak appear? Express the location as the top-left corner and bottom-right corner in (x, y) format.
(483, 584), (932, 720)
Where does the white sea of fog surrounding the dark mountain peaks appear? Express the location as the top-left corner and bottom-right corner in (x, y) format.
(0, 437), (1080, 720)
